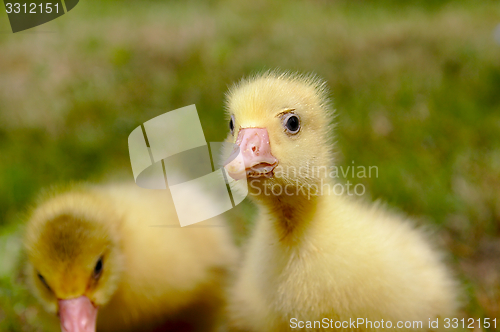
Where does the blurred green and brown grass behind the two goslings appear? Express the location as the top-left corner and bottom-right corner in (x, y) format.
(0, 0), (500, 331)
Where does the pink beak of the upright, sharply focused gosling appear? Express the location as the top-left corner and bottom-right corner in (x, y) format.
(224, 128), (278, 180)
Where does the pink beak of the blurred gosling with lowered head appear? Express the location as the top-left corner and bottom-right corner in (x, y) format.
(59, 296), (97, 332)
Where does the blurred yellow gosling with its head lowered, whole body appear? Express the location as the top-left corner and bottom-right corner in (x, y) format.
(25, 184), (239, 331)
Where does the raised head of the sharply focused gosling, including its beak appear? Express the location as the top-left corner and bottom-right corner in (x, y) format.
(225, 72), (332, 192)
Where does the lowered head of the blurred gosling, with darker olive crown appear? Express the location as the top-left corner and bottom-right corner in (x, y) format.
(25, 193), (122, 332)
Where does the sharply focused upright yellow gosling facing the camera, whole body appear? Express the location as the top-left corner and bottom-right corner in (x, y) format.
(226, 72), (457, 332)
